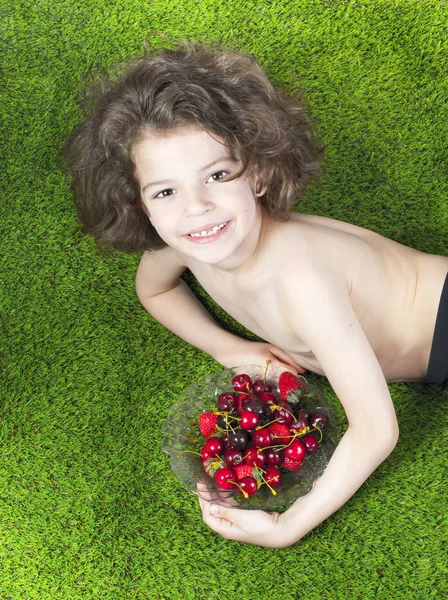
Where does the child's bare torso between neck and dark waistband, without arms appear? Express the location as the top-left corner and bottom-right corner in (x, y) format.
(182, 213), (448, 381)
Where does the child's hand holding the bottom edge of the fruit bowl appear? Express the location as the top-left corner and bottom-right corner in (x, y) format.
(199, 498), (295, 548)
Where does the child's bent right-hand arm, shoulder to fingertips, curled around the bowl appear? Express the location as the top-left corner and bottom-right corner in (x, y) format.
(201, 271), (398, 548)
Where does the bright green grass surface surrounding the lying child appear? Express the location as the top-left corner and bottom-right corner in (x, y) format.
(0, 0), (448, 600)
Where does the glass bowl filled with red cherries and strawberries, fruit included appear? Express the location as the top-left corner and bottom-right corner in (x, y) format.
(162, 361), (337, 510)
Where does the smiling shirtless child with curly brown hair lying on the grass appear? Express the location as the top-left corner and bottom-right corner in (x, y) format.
(69, 45), (448, 547)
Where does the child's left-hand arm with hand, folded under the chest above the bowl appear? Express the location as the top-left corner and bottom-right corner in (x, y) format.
(136, 247), (304, 373)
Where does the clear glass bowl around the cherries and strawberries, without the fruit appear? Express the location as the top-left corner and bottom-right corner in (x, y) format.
(162, 365), (338, 510)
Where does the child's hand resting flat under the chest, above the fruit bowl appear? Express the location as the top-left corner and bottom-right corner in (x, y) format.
(215, 338), (306, 375)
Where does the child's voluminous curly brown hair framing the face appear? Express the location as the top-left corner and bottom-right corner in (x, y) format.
(65, 42), (323, 252)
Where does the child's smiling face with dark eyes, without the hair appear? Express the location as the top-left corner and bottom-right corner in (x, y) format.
(133, 127), (265, 268)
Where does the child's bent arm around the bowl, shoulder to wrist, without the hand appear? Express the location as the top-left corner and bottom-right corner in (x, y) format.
(280, 274), (398, 541)
